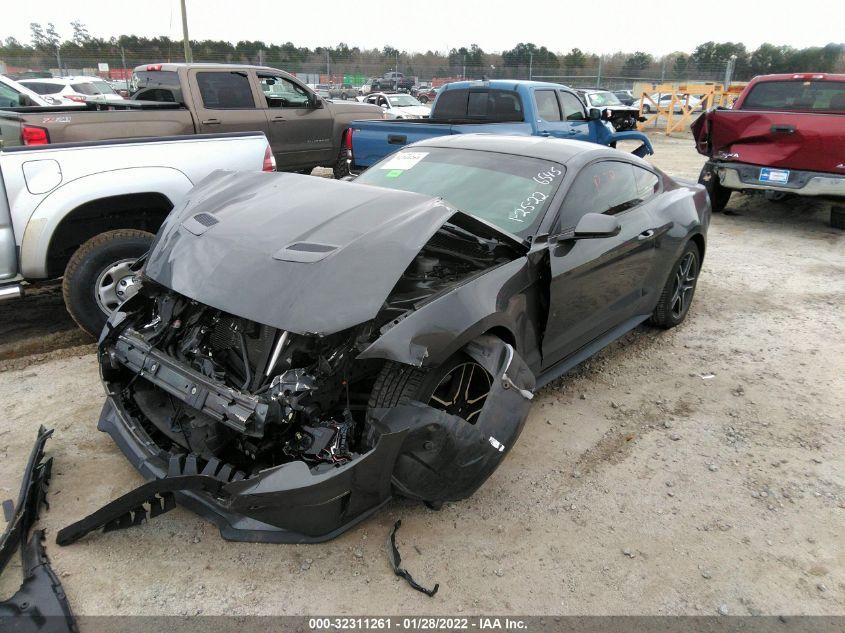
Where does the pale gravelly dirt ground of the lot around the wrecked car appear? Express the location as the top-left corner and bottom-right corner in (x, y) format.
(0, 131), (845, 615)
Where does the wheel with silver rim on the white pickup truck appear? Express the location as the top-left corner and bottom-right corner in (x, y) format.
(62, 229), (155, 338)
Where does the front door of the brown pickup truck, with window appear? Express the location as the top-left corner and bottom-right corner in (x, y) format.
(257, 71), (339, 169)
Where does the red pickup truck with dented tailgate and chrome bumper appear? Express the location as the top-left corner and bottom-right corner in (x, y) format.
(692, 73), (845, 228)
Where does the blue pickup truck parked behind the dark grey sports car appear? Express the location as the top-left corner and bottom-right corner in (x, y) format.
(346, 79), (654, 170)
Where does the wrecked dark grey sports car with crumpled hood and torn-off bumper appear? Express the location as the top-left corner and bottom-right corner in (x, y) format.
(60, 135), (710, 542)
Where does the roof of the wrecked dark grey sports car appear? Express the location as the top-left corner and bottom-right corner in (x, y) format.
(412, 134), (647, 166)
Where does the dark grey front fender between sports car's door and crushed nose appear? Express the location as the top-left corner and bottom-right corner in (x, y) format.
(359, 257), (537, 367)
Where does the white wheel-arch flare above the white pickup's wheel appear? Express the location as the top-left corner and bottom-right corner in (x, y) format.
(21, 167), (193, 279)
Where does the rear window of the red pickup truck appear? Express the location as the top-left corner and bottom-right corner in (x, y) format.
(742, 81), (845, 114)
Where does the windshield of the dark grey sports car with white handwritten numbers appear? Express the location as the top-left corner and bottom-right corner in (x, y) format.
(355, 147), (564, 237)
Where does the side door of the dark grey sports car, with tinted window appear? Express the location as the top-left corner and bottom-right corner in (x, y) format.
(543, 160), (660, 368)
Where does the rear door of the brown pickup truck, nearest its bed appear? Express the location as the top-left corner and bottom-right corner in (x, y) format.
(188, 69), (268, 141)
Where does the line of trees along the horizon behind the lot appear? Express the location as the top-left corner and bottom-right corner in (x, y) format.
(0, 21), (845, 81)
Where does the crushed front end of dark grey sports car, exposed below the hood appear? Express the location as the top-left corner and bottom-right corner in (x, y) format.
(89, 283), (403, 542)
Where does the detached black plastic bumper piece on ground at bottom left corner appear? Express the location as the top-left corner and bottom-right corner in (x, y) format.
(0, 427), (78, 633)
